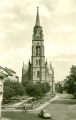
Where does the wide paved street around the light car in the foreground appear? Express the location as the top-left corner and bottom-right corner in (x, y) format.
(2, 94), (76, 120)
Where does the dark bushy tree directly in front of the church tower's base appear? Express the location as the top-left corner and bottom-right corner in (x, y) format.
(26, 82), (50, 99)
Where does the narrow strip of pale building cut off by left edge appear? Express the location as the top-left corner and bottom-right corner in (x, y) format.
(0, 73), (5, 120)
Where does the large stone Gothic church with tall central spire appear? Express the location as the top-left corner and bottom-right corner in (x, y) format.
(22, 7), (55, 94)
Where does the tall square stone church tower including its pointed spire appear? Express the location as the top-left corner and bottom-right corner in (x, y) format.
(31, 7), (45, 83)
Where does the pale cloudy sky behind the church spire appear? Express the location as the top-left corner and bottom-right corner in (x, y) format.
(0, 0), (76, 81)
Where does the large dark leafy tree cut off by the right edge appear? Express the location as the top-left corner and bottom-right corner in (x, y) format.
(64, 65), (76, 98)
